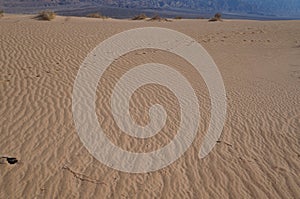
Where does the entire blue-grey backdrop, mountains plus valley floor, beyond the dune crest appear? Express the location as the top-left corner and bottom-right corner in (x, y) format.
(0, 0), (300, 19)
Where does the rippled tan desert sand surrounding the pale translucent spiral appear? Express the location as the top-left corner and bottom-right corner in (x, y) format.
(0, 15), (300, 199)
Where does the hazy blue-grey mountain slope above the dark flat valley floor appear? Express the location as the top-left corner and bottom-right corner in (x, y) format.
(0, 0), (300, 17)
